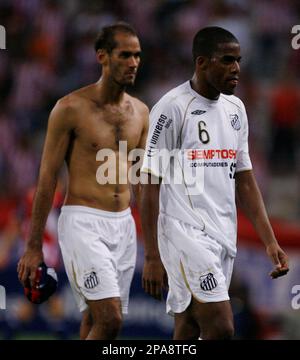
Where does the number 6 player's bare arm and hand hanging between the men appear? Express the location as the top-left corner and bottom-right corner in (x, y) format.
(141, 175), (167, 300)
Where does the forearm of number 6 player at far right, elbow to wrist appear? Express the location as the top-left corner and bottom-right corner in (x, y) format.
(237, 174), (276, 246)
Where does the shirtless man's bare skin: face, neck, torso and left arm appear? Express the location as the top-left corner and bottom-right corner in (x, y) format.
(18, 32), (149, 284)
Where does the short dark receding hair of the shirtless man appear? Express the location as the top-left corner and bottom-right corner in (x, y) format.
(94, 21), (137, 54)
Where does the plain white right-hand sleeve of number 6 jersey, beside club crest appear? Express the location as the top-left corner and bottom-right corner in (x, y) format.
(236, 102), (252, 172)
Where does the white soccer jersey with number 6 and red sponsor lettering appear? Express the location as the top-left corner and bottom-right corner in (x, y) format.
(141, 81), (252, 256)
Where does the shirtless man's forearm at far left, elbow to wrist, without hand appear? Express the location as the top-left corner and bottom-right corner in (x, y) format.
(26, 178), (57, 250)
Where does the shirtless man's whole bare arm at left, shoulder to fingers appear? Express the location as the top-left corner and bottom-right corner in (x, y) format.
(18, 101), (72, 284)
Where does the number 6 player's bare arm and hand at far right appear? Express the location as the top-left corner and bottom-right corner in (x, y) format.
(236, 170), (289, 278)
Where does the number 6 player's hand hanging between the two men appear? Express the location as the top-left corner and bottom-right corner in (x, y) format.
(143, 258), (168, 300)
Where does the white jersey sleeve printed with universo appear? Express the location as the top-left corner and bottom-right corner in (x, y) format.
(141, 100), (181, 178)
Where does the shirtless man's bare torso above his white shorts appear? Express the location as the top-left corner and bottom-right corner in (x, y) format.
(65, 85), (145, 211)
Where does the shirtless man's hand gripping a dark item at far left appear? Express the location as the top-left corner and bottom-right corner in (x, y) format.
(17, 249), (44, 286)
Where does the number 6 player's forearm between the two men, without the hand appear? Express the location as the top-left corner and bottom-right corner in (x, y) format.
(141, 184), (159, 260)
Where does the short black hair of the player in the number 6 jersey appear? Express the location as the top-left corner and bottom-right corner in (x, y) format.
(193, 26), (239, 62)
